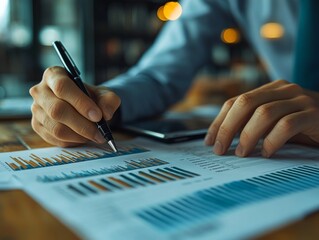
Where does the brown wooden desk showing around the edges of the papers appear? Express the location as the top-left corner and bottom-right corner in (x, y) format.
(0, 120), (319, 240)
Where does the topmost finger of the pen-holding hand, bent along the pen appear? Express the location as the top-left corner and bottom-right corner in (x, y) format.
(44, 68), (102, 122)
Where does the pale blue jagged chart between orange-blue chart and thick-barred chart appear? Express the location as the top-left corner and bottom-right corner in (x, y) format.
(37, 158), (168, 183)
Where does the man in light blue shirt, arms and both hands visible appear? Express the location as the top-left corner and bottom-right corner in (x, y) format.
(30, 0), (319, 157)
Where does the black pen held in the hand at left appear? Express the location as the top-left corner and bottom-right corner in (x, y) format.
(52, 41), (117, 152)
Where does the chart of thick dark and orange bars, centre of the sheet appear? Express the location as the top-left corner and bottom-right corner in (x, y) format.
(64, 166), (200, 197)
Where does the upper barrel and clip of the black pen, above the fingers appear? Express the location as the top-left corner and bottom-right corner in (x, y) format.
(52, 41), (81, 77)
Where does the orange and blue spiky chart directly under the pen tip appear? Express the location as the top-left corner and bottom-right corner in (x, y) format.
(5, 146), (149, 171)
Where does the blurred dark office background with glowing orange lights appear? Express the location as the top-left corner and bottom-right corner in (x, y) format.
(0, 0), (283, 104)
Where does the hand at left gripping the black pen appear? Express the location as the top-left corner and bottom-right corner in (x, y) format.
(30, 67), (121, 147)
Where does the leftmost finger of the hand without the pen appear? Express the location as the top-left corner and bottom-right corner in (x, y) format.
(204, 97), (236, 146)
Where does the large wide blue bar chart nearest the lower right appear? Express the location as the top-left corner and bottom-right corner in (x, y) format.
(136, 165), (319, 231)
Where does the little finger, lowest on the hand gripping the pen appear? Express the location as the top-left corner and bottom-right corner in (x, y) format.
(31, 115), (85, 147)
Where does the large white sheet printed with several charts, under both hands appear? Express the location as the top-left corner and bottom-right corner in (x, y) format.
(0, 139), (319, 239)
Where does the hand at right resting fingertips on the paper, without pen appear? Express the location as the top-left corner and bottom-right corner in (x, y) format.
(205, 80), (319, 157)
